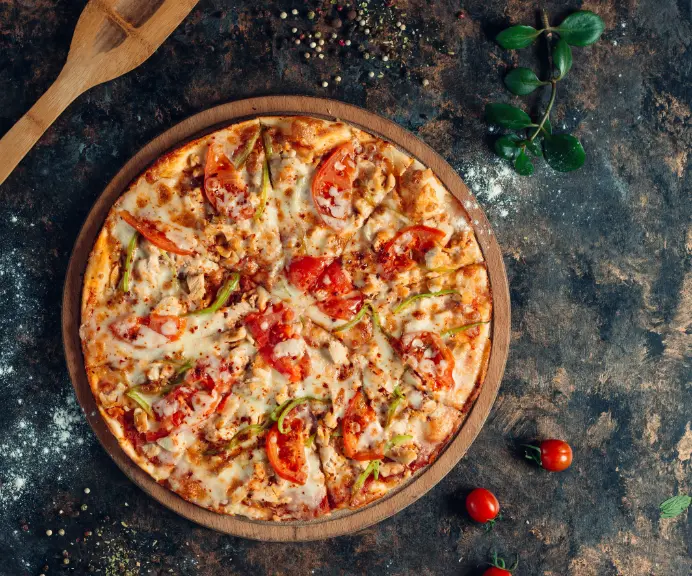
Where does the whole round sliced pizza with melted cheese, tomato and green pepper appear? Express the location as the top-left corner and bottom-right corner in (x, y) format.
(80, 117), (492, 521)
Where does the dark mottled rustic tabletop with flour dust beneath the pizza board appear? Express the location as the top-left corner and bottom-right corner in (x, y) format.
(0, 0), (692, 576)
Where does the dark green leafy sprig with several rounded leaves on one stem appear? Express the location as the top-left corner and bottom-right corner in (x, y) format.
(485, 10), (605, 176)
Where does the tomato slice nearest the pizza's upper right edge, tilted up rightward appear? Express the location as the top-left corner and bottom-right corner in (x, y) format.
(379, 225), (445, 278)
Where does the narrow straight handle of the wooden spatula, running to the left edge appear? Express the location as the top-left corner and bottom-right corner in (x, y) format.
(0, 66), (86, 184)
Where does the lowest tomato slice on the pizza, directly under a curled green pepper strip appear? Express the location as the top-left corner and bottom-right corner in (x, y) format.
(266, 418), (308, 486)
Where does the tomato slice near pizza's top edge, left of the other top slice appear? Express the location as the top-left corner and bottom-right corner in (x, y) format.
(204, 142), (255, 220)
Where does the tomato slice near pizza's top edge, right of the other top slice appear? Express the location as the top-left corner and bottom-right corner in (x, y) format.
(312, 142), (356, 227)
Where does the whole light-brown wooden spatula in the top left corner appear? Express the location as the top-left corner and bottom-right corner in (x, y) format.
(0, 0), (198, 184)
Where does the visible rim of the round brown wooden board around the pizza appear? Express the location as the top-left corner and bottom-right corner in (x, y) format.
(62, 96), (510, 542)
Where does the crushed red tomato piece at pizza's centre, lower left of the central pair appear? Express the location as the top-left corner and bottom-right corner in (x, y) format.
(245, 304), (311, 382)
